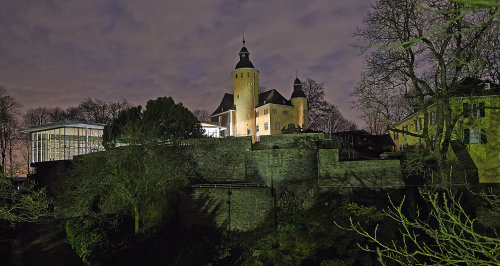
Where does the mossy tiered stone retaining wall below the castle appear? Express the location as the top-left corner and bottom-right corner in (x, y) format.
(38, 134), (404, 231)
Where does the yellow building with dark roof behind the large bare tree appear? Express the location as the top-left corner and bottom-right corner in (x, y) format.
(389, 78), (500, 183)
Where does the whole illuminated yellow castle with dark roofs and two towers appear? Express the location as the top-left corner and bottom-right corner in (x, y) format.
(210, 40), (308, 142)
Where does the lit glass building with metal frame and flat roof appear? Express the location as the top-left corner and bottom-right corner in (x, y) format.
(21, 121), (104, 164)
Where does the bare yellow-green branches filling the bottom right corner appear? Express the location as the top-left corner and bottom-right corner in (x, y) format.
(342, 189), (500, 265)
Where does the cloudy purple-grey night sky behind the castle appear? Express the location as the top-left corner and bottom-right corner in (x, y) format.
(0, 0), (371, 127)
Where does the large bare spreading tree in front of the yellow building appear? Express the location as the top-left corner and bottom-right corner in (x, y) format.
(356, 0), (499, 178)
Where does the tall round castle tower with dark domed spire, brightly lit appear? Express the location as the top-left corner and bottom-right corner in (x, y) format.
(231, 39), (259, 141)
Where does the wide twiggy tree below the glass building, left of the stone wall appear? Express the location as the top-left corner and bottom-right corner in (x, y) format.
(66, 145), (189, 233)
